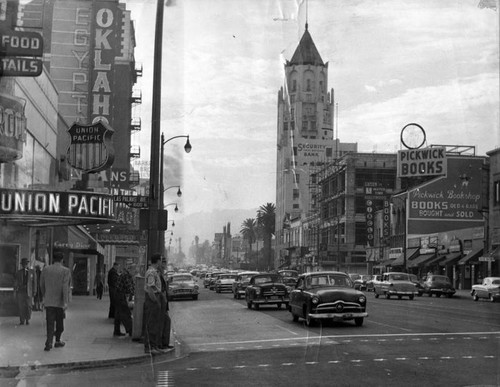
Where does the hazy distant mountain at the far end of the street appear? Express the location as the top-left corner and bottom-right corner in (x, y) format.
(173, 208), (258, 250)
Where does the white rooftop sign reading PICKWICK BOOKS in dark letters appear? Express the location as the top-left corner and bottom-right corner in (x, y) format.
(397, 146), (447, 177)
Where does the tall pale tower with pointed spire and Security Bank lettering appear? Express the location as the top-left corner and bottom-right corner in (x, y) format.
(275, 22), (357, 266)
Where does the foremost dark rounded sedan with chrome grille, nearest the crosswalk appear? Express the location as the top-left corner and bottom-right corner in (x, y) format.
(288, 271), (368, 326)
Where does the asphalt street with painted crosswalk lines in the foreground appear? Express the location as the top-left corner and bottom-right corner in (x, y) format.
(3, 288), (500, 387)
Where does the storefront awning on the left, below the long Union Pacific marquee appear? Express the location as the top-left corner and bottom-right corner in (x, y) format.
(54, 226), (105, 255)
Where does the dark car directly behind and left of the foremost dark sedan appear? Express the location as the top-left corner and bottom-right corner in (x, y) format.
(245, 273), (289, 309)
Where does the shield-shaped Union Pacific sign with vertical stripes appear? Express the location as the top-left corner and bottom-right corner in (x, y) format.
(68, 121), (115, 173)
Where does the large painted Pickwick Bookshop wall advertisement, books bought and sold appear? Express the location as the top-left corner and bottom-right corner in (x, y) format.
(408, 157), (484, 234)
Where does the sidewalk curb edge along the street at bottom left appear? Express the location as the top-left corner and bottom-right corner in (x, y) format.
(0, 348), (175, 378)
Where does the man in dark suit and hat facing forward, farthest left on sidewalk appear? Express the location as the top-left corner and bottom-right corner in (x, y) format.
(14, 258), (37, 325)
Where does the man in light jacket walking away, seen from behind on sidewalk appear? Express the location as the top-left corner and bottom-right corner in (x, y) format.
(40, 252), (71, 351)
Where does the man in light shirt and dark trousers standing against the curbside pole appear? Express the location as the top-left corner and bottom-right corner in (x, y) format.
(143, 253), (162, 355)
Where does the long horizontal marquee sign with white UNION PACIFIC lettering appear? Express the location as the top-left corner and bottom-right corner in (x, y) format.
(0, 189), (114, 221)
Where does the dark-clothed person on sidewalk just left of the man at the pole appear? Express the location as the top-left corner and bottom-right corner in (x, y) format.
(113, 267), (135, 336)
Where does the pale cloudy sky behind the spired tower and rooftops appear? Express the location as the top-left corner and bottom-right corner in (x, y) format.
(126, 0), (500, 246)
